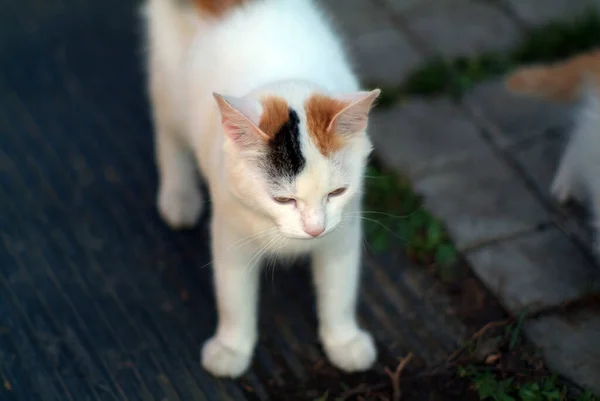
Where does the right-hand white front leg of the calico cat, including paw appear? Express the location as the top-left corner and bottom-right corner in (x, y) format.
(313, 219), (377, 372)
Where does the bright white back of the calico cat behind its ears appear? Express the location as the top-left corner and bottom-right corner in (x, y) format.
(192, 0), (358, 95)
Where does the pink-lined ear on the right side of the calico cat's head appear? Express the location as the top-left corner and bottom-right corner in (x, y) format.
(328, 89), (381, 137)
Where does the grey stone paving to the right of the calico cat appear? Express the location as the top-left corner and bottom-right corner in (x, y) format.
(323, 0), (600, 394)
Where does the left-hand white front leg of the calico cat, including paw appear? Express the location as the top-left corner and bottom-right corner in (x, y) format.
(201, 220), (261, 378)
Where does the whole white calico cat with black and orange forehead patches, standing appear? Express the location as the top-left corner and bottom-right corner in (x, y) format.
(143, 0), (380, 378)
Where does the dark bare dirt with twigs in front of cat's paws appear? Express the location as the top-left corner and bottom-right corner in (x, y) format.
(234, 256), (549, 401)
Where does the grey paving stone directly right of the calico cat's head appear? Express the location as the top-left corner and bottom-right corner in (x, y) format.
(369, 98), (487, 177)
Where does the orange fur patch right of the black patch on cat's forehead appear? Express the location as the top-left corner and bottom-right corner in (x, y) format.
(304, 94), (349, 156)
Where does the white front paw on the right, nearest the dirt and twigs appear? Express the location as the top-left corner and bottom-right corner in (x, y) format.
(324, 330), (377, 373)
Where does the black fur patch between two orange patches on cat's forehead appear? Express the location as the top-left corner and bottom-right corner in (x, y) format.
(265, 108), (306, 179)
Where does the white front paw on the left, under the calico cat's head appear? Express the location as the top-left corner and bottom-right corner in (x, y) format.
(200, 337), (252, 379)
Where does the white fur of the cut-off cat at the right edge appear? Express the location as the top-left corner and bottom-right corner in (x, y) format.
(551, 80), (600, 252)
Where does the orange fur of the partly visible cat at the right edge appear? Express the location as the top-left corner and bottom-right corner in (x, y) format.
(506, 50), (600, 102)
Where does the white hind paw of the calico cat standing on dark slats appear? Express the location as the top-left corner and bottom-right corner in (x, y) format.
(158, 187), (204, 230)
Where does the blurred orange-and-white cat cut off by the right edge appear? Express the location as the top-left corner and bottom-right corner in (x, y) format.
(506, 49), (600, 256)
